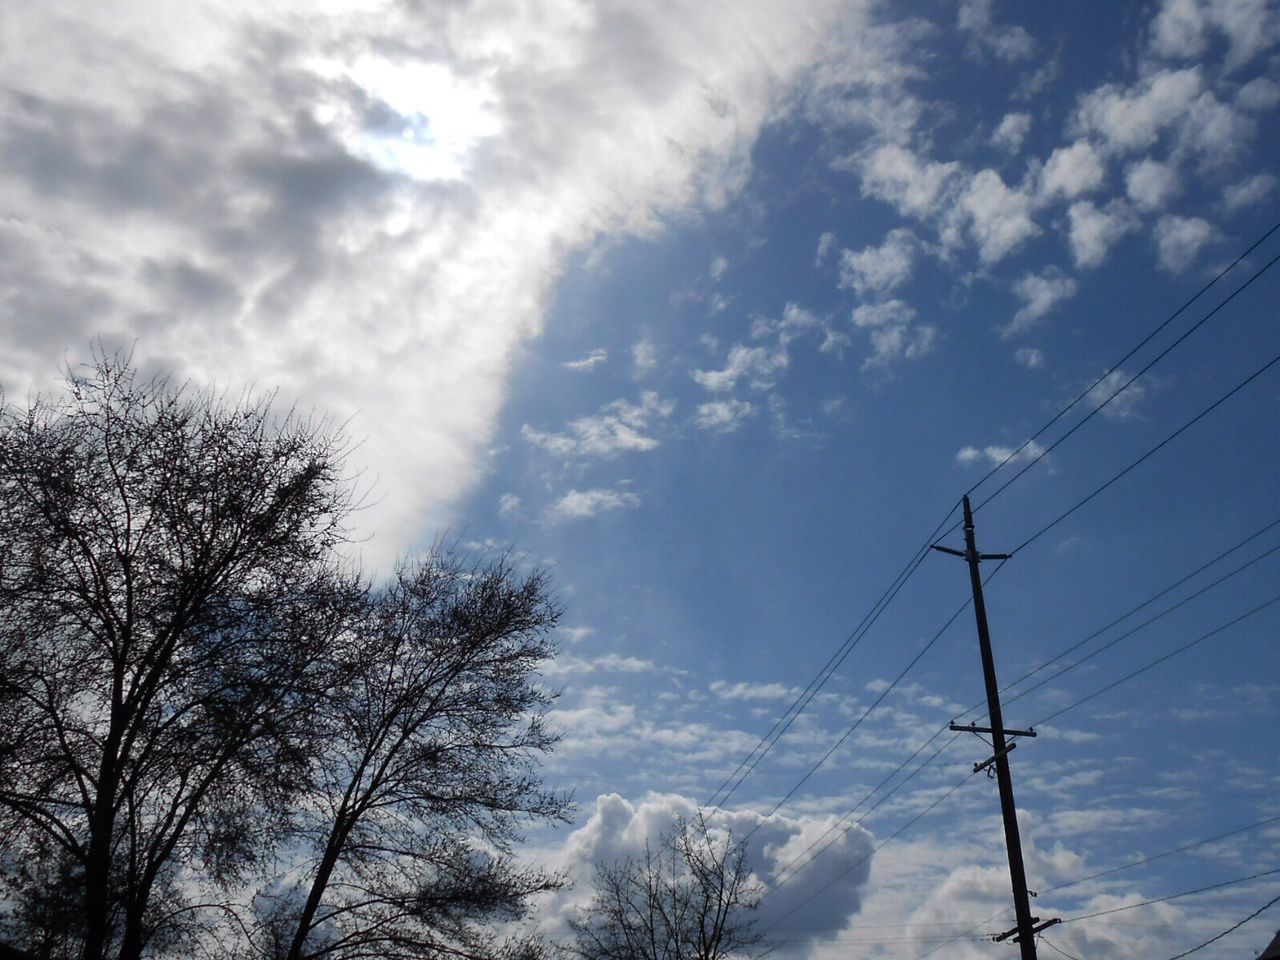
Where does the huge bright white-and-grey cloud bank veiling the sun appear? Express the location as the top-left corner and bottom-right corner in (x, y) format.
(0, 0), (864, 576)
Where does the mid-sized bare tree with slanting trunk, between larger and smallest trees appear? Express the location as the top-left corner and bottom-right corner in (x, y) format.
(259, 552), (566, 960)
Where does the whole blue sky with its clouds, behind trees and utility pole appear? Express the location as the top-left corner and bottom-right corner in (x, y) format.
(0, 0), (1280, 960)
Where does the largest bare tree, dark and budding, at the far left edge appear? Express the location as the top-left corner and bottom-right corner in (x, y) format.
(0, 356), (361, 960)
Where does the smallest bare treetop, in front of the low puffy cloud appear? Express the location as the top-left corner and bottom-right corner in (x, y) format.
(570, 820), (764, 960)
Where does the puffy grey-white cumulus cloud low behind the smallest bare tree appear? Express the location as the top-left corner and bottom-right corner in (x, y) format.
(541, 794), (873, 955)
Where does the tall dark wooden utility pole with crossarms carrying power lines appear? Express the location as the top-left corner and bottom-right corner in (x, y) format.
(933, 494), (1061, 960)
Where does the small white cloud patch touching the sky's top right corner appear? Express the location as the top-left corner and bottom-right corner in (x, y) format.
(1151, 0), (1280, 69)
